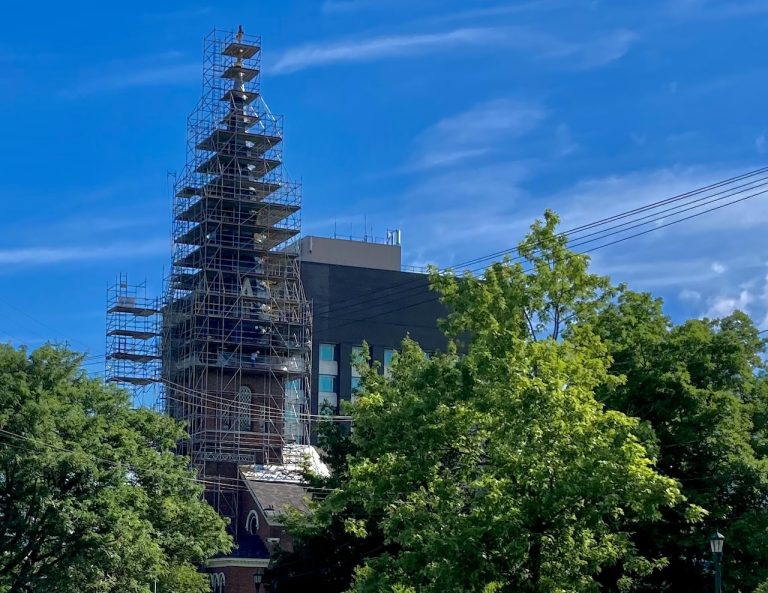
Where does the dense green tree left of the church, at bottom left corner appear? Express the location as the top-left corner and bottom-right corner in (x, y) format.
(0, 345), (231, 593)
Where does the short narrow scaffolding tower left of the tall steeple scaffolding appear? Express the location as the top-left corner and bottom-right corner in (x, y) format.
(105, 274), (160, 407)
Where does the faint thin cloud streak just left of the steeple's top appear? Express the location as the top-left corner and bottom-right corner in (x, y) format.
(59, 52), (201, 99)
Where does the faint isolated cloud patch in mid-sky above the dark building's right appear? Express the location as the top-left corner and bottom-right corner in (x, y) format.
(413, 99), (547, 169)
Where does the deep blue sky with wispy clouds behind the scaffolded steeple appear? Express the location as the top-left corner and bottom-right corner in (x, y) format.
(0, 0), (768, 366)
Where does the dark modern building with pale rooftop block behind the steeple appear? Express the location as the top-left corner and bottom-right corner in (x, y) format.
(299, 236), (446, 414)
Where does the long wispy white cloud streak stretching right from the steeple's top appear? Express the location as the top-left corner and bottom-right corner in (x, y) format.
(271, 26), (637, 74)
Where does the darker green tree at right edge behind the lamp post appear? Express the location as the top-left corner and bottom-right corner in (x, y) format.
(594, 291), (768, 593)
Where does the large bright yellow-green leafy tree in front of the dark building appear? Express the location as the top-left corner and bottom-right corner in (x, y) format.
(272, 213), (695, 593)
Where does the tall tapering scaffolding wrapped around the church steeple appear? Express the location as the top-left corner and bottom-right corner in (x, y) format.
(162, 29), (311, 529)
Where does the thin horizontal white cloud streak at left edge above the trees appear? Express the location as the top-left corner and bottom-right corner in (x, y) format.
(0, 239), (168, 266)
